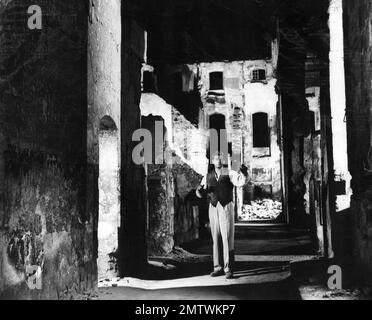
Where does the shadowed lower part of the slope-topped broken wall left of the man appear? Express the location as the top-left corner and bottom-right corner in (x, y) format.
(147, 158), (201, 255)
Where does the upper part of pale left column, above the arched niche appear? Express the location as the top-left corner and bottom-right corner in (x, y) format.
(88, 0), (122, 134)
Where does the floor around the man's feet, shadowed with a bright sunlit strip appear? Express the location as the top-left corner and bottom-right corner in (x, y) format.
(98, 228), (317, 300)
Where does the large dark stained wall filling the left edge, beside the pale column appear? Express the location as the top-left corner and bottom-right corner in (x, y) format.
(0, 0), (96, 299)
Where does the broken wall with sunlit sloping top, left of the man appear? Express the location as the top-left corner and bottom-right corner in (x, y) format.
(141, 93), (203, 255)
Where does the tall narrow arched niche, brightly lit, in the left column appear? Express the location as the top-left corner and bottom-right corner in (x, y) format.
(97, 116), (120, 280)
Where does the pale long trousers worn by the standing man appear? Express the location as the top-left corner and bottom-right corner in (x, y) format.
(209, 202), (235, 272)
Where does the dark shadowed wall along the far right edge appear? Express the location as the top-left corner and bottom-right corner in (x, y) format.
(344, 0), (372, 284)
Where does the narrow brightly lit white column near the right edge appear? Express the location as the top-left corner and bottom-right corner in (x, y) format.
(329, 0), (352, 212)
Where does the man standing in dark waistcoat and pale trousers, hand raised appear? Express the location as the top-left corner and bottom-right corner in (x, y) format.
(196, 153), (247, 279)
